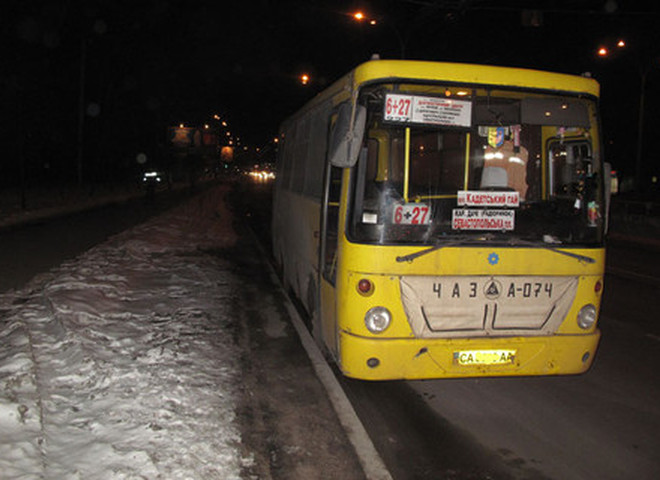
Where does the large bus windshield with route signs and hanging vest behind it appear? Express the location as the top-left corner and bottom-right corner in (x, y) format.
(348, 83), (605, 247)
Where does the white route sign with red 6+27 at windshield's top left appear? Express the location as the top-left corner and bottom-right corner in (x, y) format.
(384, 93), (472, 127)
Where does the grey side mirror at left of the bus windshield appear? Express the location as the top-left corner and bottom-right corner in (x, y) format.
(328, 102), (367, 168)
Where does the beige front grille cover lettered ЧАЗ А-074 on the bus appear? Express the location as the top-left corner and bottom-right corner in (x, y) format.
(400, 276), (578, 338)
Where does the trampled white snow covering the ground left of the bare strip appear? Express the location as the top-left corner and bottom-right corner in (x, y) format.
(0, 189), (251, 480)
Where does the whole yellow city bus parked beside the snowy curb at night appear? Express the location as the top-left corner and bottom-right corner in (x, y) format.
(272, 60), (609, 380)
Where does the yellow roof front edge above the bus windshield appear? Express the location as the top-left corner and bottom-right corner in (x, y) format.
(354, 60), (600, 97)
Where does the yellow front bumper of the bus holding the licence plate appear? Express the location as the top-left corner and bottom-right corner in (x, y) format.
(338, 330), (600, 380)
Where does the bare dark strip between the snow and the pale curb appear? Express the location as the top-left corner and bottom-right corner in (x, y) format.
(217, 226), (368, 480)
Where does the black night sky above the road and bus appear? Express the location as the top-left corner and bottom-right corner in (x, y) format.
(0, 0), (660, 186)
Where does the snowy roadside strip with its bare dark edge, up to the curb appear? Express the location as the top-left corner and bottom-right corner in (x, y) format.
(0, 185), (364, 480)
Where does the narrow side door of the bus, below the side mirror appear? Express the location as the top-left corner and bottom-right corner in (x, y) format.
(320, 165), (343, 354)
